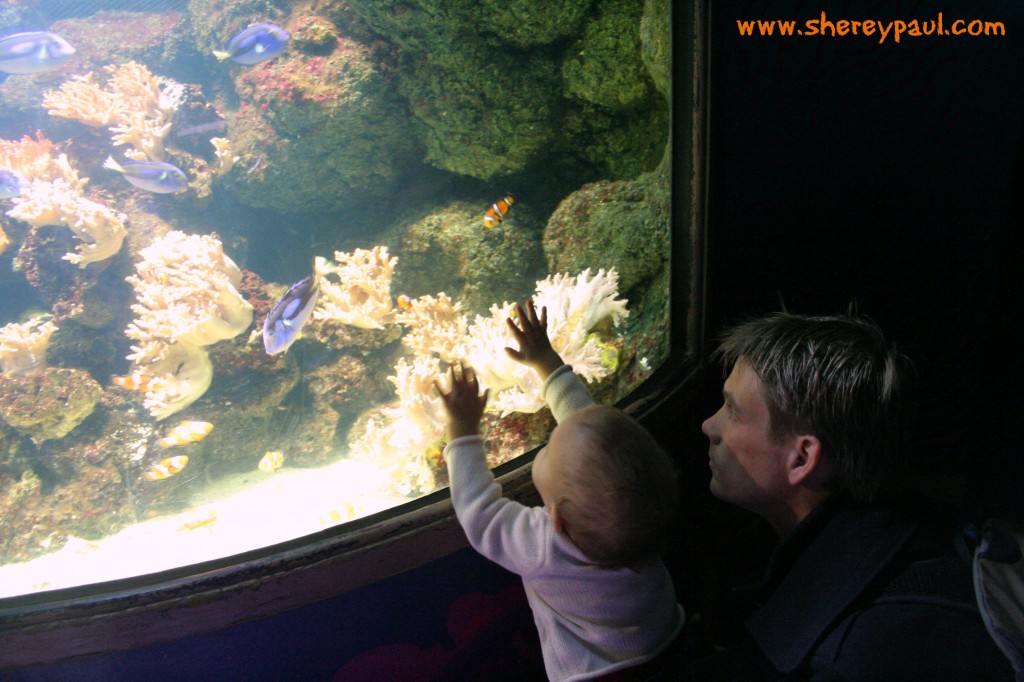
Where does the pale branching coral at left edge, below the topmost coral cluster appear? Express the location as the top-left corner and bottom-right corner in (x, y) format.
(0, 135), (125, 267)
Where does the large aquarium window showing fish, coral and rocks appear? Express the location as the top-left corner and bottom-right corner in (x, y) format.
(0, 0), (688, 596)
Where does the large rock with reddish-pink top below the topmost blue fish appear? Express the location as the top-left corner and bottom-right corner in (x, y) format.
(221, 16), (422, 211)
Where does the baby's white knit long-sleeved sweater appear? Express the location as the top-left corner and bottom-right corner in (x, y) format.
(444, 366), (683, 681)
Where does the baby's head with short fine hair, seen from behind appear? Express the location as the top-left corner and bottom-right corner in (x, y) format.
(534, 406), (677, 565)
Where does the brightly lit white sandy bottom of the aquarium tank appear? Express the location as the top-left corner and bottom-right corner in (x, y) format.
(0, 460), (410, 598)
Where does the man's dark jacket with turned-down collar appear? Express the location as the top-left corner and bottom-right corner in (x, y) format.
(689, 498), (1013, 682)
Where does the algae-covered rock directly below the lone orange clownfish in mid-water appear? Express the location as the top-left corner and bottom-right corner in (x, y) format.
(391, 196), (545, 314)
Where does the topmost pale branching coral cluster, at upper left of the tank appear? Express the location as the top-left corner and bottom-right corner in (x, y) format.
(43, 61), (184, 161)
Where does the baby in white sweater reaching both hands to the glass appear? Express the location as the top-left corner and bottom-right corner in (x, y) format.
(436, 301), (683, 680)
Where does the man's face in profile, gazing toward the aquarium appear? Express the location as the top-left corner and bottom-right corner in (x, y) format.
(700, 357), (788, 519)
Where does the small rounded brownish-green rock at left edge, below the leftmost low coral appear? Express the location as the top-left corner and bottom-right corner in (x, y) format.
(0, 368), (103, 442)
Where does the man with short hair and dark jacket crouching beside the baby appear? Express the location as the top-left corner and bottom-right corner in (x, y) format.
(690, 313), (1013, 682)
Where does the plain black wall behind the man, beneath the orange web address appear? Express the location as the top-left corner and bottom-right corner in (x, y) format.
(693, 0), (1024, 512)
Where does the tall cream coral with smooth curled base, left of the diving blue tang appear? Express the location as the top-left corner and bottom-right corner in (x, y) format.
(125, 231), (253, 419)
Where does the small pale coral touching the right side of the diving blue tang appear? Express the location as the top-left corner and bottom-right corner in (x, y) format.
(313, 246), (398, 329)
